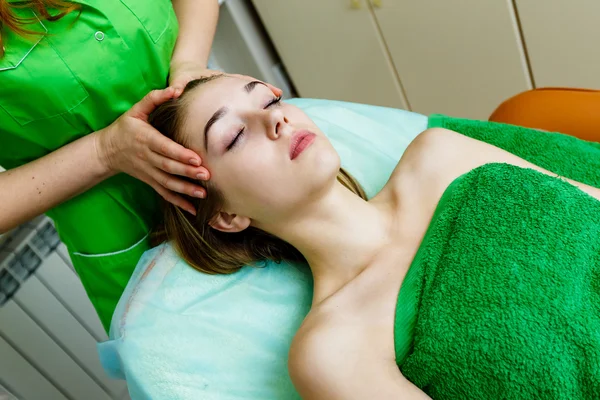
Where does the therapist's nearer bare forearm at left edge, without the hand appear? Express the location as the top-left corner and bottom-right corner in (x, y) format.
(0, 134), (114, 233)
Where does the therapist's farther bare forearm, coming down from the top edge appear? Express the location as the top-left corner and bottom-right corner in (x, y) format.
(171, 0), (219, 67)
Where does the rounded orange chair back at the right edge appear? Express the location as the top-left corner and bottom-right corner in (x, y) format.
(490, 88), (600, 142)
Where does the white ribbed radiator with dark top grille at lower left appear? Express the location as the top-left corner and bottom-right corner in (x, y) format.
(0, 217), (129, 400)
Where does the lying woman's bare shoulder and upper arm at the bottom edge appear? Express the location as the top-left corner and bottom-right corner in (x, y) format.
(288, 322), (429, 400)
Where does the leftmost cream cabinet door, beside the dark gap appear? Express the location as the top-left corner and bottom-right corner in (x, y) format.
(248, 0), (406, 108)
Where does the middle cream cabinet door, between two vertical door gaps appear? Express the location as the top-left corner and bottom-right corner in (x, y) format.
(373, 0), (531, 119)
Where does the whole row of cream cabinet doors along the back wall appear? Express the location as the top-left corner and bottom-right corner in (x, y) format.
(253, 0), (584, 119)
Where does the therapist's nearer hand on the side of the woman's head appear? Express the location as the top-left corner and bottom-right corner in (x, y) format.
(95, 88), (209, 215)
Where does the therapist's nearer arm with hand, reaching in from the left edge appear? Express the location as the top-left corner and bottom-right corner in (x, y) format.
(0, 89), (208, 233)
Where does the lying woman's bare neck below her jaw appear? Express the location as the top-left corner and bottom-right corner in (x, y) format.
(261, 181), (390, 304)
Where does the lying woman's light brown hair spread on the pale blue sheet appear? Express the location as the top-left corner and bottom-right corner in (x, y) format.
(149, 76), (367, 274)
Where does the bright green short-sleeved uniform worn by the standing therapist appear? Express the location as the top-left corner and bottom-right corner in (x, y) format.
(0, 0), (178, 330)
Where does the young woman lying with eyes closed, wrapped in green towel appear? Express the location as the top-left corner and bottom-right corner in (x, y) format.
(151, 76), (600, 400)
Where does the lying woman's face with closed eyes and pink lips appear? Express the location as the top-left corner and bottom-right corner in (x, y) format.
(183, 76), (340, 223)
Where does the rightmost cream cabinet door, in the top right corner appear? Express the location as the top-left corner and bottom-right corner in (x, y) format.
(516, 0), (600, 89)
